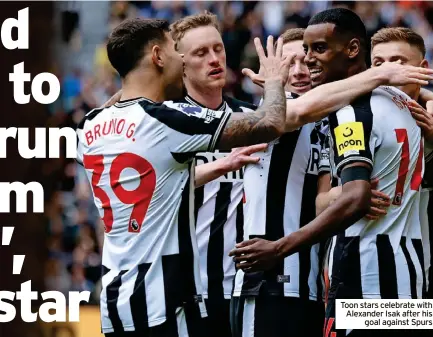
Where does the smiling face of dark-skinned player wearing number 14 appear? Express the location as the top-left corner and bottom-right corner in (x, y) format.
(304, 23), (349, 87)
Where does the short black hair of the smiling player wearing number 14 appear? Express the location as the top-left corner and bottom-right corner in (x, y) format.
(308, 8), (368, 53)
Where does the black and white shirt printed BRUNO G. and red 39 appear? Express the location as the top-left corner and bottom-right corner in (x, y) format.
(77, 98), (230, 333)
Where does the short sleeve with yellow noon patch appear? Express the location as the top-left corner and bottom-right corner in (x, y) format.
(329, 99), (375, 177)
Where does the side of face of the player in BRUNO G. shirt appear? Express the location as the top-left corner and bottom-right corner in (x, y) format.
(162, 33), (185, 99)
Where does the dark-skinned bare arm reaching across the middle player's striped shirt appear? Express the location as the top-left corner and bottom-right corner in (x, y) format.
(229, 163), (371, 272)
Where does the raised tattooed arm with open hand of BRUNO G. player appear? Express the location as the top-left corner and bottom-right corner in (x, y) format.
(217, 36), (295, 150)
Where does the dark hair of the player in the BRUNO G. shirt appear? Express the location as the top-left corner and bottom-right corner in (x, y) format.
(107, 19), (169, 78)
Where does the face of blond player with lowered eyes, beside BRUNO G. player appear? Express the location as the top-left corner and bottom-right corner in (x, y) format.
(179, 26), (226, 89)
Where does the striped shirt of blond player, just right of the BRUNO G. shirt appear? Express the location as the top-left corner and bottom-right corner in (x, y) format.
(171, 96), (257, 299)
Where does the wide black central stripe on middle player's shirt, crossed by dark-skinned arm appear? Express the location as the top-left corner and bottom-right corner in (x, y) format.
(265, 128), (302, 294)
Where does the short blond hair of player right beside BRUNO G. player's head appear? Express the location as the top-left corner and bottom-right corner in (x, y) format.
(170, 11), (221, 50)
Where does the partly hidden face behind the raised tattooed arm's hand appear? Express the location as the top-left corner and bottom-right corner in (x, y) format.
(283, 40), (311, 95)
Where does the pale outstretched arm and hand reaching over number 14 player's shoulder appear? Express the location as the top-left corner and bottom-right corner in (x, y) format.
(286, 62), (433, 131)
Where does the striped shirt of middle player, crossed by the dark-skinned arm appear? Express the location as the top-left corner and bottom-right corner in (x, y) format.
(233, 93), (327, 300)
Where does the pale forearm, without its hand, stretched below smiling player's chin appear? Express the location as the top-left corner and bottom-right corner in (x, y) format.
(286, 68), (385, 131)
